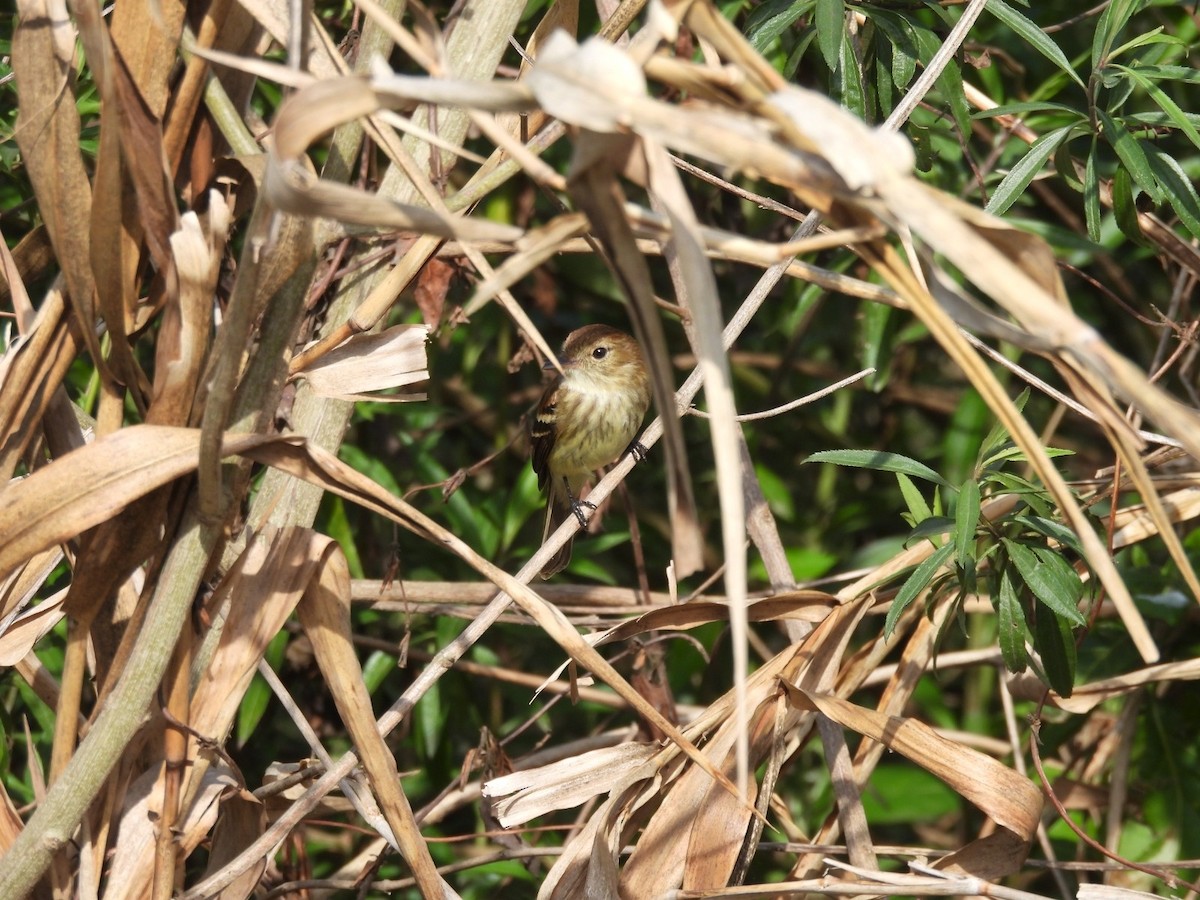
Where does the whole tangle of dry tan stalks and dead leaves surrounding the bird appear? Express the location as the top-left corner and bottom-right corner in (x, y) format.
(0, 0), (1200, 899)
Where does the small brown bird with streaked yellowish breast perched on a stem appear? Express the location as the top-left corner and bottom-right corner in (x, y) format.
(529, 325), (650, 578)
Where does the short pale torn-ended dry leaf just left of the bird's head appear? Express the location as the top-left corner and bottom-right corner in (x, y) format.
(299, 325), (430, 400)
